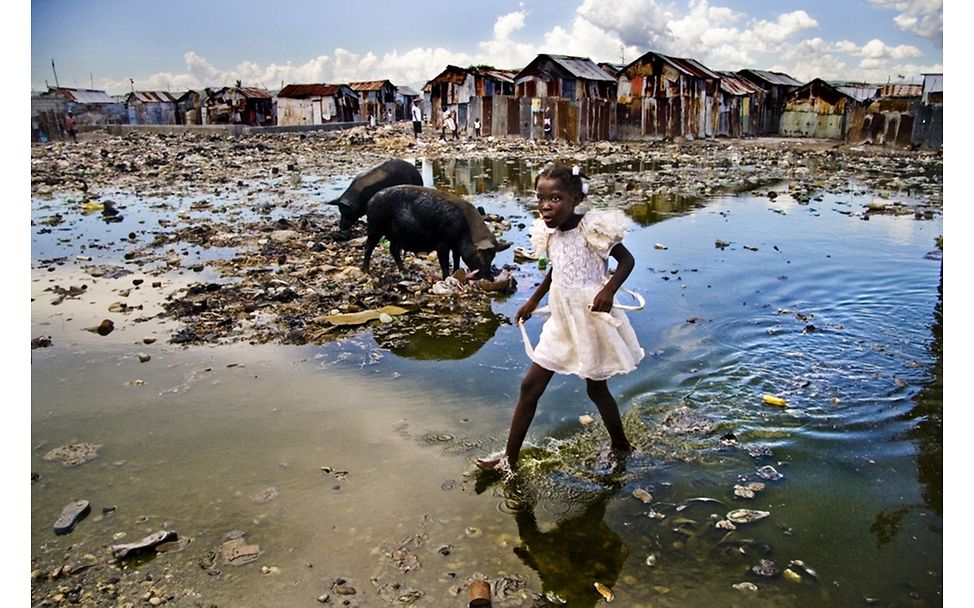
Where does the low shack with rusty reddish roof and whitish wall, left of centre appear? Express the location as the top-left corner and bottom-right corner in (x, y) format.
(277, 84), (359, 126)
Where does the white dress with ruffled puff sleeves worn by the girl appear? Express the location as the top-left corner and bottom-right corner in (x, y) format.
(528, 210), (645, 380)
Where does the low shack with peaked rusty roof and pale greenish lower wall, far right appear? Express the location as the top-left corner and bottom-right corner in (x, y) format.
(778, 78), (863, 140)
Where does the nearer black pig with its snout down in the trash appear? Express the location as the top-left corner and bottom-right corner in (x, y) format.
(362, 186), (511, 279)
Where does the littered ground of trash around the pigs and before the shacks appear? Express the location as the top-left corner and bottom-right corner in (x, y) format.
(31, 123), (943, 346)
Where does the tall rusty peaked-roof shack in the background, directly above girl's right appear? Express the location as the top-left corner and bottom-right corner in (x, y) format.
(618, 52), (720, 138)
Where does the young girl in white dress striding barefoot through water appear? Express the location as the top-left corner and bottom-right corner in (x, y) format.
(477, 165), (644, 470)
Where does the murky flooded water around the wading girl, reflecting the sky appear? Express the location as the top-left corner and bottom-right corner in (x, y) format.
(31, 160), (943, 607)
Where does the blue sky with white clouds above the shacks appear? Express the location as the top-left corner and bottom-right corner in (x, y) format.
(30, 0), (944, 95)
